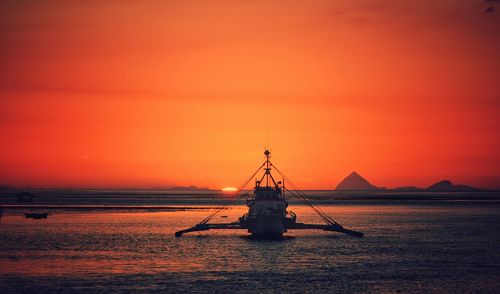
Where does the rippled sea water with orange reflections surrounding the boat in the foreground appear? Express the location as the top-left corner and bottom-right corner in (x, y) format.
(0, 201), (500, 293)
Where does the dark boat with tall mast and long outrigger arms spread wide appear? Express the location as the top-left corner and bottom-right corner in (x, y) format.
(175, 149), (363, 238)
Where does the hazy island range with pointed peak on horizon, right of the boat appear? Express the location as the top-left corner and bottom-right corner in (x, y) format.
(335, 171), (484, 192)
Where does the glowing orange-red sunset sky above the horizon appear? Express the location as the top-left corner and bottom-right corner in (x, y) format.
(0, 0), (500, 189)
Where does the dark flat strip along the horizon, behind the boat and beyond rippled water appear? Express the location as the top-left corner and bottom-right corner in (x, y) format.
(0, 190), (500, 211)
